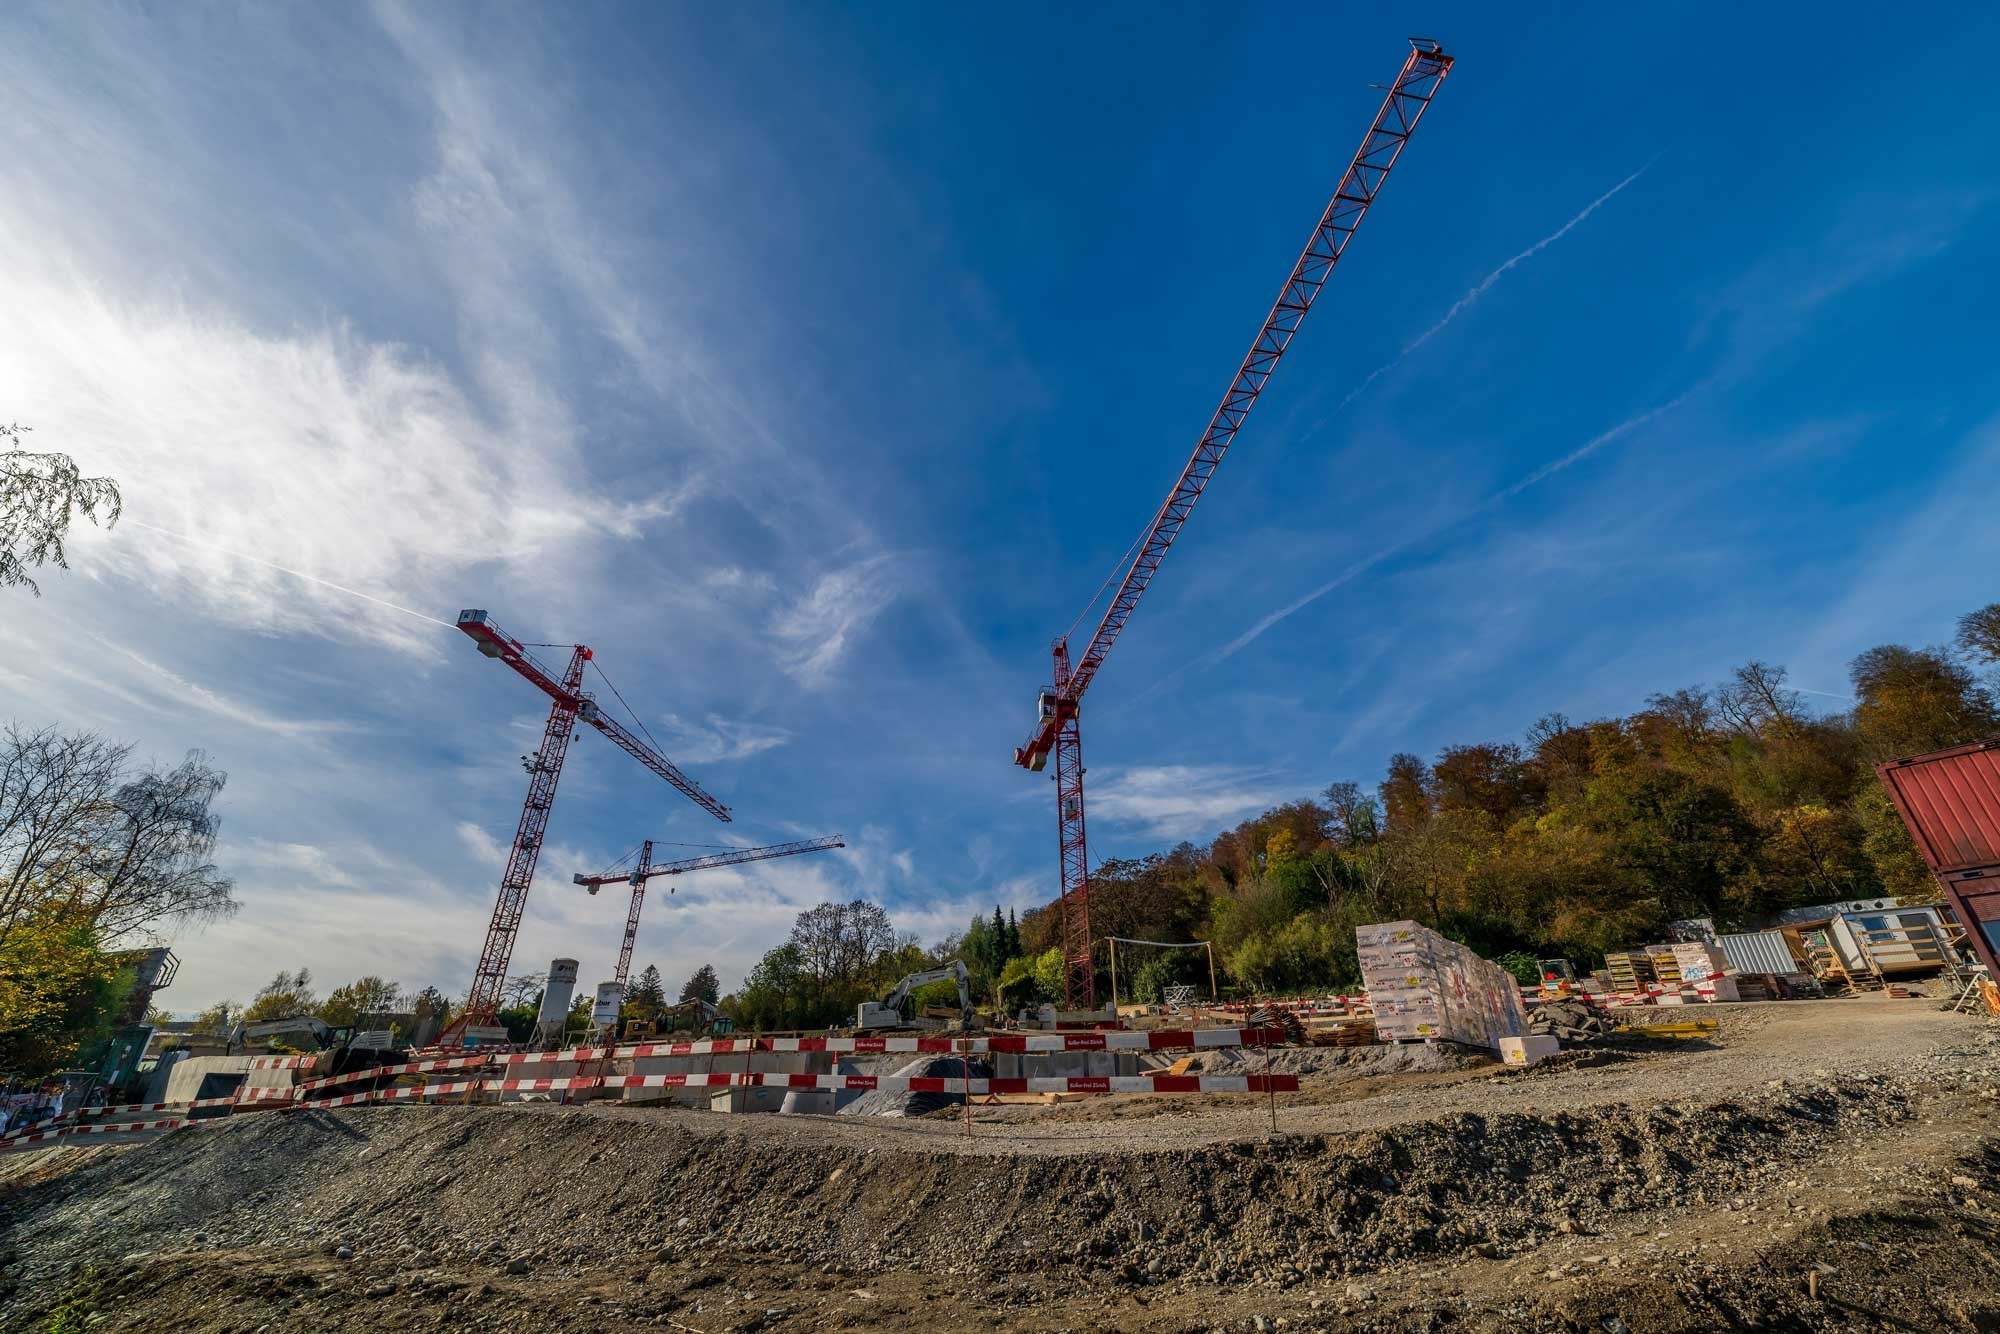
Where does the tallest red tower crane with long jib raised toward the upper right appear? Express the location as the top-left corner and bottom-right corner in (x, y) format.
(1014, 38), (1452, 1010)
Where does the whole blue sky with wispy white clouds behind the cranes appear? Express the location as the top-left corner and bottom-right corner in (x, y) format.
(0, 4), (2000, 1008)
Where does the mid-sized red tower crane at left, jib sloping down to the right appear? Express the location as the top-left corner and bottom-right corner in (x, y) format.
(438, 610), (730, 1046)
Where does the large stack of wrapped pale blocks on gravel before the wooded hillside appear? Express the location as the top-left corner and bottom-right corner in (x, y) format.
(1354, 922), (1528, 1052)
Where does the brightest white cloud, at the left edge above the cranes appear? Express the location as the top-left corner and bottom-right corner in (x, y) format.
(0, 247), (658, 652)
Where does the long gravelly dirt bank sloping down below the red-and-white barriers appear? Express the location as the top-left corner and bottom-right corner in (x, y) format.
(0, 1080), (1936, 1290)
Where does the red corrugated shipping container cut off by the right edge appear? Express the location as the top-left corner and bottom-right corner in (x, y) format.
(1876, 740), (2000, 980)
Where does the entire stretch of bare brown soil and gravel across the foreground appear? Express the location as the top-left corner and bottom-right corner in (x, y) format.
(0, 998), (2000, 1334)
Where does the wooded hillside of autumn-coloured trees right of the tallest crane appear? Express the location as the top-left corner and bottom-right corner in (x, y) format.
(992, 602), (2000, 998)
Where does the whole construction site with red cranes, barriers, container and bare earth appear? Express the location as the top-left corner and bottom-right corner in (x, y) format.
(0, 26), (2000, 1334)
